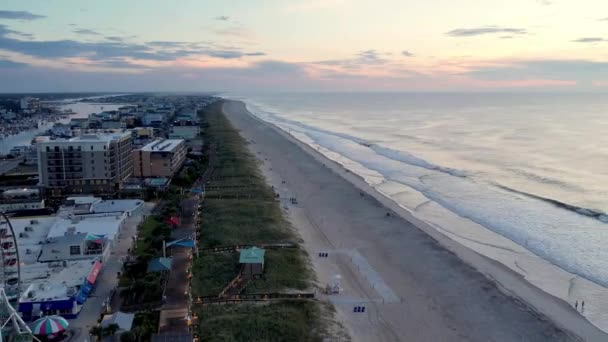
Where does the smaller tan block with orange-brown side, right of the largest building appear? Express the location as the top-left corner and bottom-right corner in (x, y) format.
(133, 139), (187, 177)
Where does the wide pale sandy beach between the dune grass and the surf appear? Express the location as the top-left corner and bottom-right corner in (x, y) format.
(224, 101), (608, 341)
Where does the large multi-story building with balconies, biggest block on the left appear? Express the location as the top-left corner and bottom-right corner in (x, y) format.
(38, 132), (133, 197)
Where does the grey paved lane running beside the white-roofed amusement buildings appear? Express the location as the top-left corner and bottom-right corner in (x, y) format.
(70, 202), (155, 342)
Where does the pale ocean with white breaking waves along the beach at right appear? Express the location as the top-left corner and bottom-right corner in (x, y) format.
(224, 93), (608, 330)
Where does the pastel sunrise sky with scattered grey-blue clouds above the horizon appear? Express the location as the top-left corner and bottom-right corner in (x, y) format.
(0, 0), (608, 92)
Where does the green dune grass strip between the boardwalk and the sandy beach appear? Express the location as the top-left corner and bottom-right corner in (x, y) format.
(192, 103), (323, 341)
